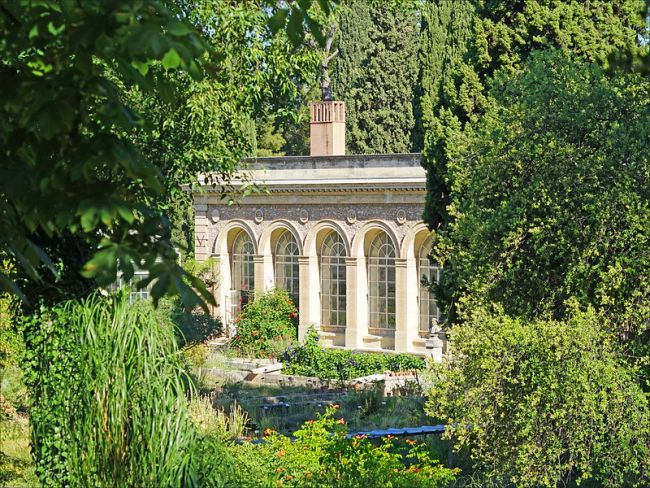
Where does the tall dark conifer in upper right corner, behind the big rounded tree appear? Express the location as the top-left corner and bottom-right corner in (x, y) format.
(420, 0), (648, 227)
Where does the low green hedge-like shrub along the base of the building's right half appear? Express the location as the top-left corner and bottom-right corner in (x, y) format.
(281, 329), (425, 380)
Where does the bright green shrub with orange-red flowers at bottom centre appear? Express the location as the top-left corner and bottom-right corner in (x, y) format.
(192, 408), (458, 488)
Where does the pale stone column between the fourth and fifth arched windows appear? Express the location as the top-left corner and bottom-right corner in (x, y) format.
(395, 258), (419, 352)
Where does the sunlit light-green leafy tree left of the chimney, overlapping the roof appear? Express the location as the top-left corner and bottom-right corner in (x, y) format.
(121, 0), (322, 257)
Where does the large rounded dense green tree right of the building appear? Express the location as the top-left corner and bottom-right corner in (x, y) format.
(436, 51), (650, 356)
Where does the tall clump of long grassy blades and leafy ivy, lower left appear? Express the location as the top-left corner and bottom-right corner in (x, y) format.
(24, 294), (194, 487)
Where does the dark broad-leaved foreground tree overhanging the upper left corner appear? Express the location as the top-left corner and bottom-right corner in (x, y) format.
(0, 0), (329, 305)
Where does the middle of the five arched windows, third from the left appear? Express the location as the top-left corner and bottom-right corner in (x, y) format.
(320, 232), (346, 326)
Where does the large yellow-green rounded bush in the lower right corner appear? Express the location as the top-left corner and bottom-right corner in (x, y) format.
(426, 305), (650, 487)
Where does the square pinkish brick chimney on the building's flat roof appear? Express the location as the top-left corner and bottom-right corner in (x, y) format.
(309, 101), (345, 156)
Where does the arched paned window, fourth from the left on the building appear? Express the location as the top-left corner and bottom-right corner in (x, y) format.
(368, 232), (395, 329)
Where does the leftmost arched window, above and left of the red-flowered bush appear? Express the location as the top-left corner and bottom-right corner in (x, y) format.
(230, 231), (255, 318)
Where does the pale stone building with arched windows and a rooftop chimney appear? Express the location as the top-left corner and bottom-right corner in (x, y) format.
(194, 101), (439, 353)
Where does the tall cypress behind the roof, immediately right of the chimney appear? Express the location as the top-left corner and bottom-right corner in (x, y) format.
(332, 0), (419, 154)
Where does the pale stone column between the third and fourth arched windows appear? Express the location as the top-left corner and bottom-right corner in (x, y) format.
(345, 257), (368, 349)
